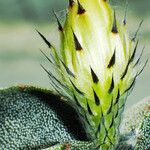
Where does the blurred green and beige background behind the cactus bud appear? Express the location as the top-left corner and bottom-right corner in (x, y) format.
(0, 0), (150, 106)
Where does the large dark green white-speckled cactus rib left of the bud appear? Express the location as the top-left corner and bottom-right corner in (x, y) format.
(0, 87), (93, 150)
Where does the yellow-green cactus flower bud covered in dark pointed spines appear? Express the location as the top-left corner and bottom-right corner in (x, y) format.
(39, 0), (146, 150)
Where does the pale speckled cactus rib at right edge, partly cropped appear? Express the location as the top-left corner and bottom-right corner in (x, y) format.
(120, 98), (150, 150)
